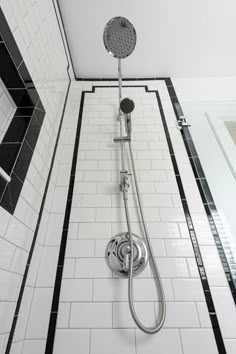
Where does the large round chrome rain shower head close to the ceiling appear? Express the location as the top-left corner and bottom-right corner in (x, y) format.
(103, 17), (136, 59)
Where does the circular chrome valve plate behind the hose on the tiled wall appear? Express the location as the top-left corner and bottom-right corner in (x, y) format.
(106, 232), (148, 278)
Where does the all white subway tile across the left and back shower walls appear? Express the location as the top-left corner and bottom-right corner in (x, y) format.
(0, 10), (232, 348)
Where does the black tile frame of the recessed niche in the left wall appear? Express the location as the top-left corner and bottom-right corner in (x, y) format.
(0, 8), (45, 214)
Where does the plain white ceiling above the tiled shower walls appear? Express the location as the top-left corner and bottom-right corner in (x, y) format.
(59, 0), (236, 78)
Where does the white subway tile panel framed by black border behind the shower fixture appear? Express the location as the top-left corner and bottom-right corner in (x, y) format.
(45, 82), (221, 354)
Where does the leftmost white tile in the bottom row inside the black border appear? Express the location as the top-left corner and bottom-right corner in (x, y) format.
(53, 329), (90, 354)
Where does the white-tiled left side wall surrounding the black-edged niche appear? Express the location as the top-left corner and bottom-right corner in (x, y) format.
(0, 0), (68, 353)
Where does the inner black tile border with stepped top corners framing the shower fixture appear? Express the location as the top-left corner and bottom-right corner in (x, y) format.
(45, 85), (226, 354)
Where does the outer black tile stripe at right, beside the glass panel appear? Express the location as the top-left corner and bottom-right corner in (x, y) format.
(165, 78), (236, 305)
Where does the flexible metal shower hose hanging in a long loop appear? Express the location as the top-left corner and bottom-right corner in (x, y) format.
(123, 142), (166, 334)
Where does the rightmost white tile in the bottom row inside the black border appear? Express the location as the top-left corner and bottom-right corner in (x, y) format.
(180, 329), (219, 354)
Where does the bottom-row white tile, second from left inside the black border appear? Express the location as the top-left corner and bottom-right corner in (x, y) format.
(90, 329), (135, 354)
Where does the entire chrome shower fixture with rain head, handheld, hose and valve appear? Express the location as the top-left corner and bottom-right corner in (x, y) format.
(103, 17), (166, 334)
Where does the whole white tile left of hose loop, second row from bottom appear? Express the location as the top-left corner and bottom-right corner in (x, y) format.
(69, 302), (112, 328)
